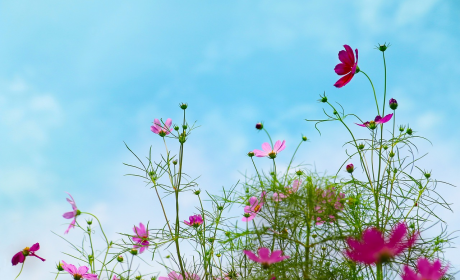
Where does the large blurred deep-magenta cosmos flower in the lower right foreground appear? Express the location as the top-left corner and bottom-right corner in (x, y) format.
(345, 223), (417, 264)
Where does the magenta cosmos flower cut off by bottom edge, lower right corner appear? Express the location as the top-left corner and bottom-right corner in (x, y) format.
(402, 258), (448, 280)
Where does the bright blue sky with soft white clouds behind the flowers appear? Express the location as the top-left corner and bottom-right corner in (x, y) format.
(0, 0), (460, 279)
